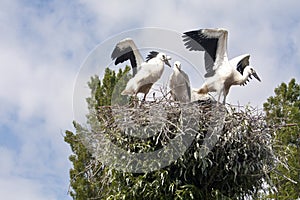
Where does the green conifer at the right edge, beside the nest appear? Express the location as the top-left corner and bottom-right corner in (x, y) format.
(264, 79), (300, 199)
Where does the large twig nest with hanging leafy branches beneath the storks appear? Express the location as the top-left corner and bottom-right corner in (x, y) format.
(76, 97), (274, 196)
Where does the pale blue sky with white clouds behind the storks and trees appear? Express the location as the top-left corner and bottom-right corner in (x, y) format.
(0, 0), (300, 200)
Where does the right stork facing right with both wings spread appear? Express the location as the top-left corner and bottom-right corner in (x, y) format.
(183, 29), (260, 104)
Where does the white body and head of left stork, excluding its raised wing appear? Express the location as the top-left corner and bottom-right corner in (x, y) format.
(121, 51), (171, 101)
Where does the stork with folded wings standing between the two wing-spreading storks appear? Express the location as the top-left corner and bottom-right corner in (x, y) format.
(169, 61), (191, 103)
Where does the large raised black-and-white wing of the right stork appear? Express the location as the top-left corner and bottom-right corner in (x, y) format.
(183, 29), (228, 77)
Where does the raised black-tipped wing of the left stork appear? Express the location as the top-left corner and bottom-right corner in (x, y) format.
(111, 38), (144, 76)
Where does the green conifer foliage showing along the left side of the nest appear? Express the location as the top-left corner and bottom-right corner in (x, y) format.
(64, 67), (130, 200)
